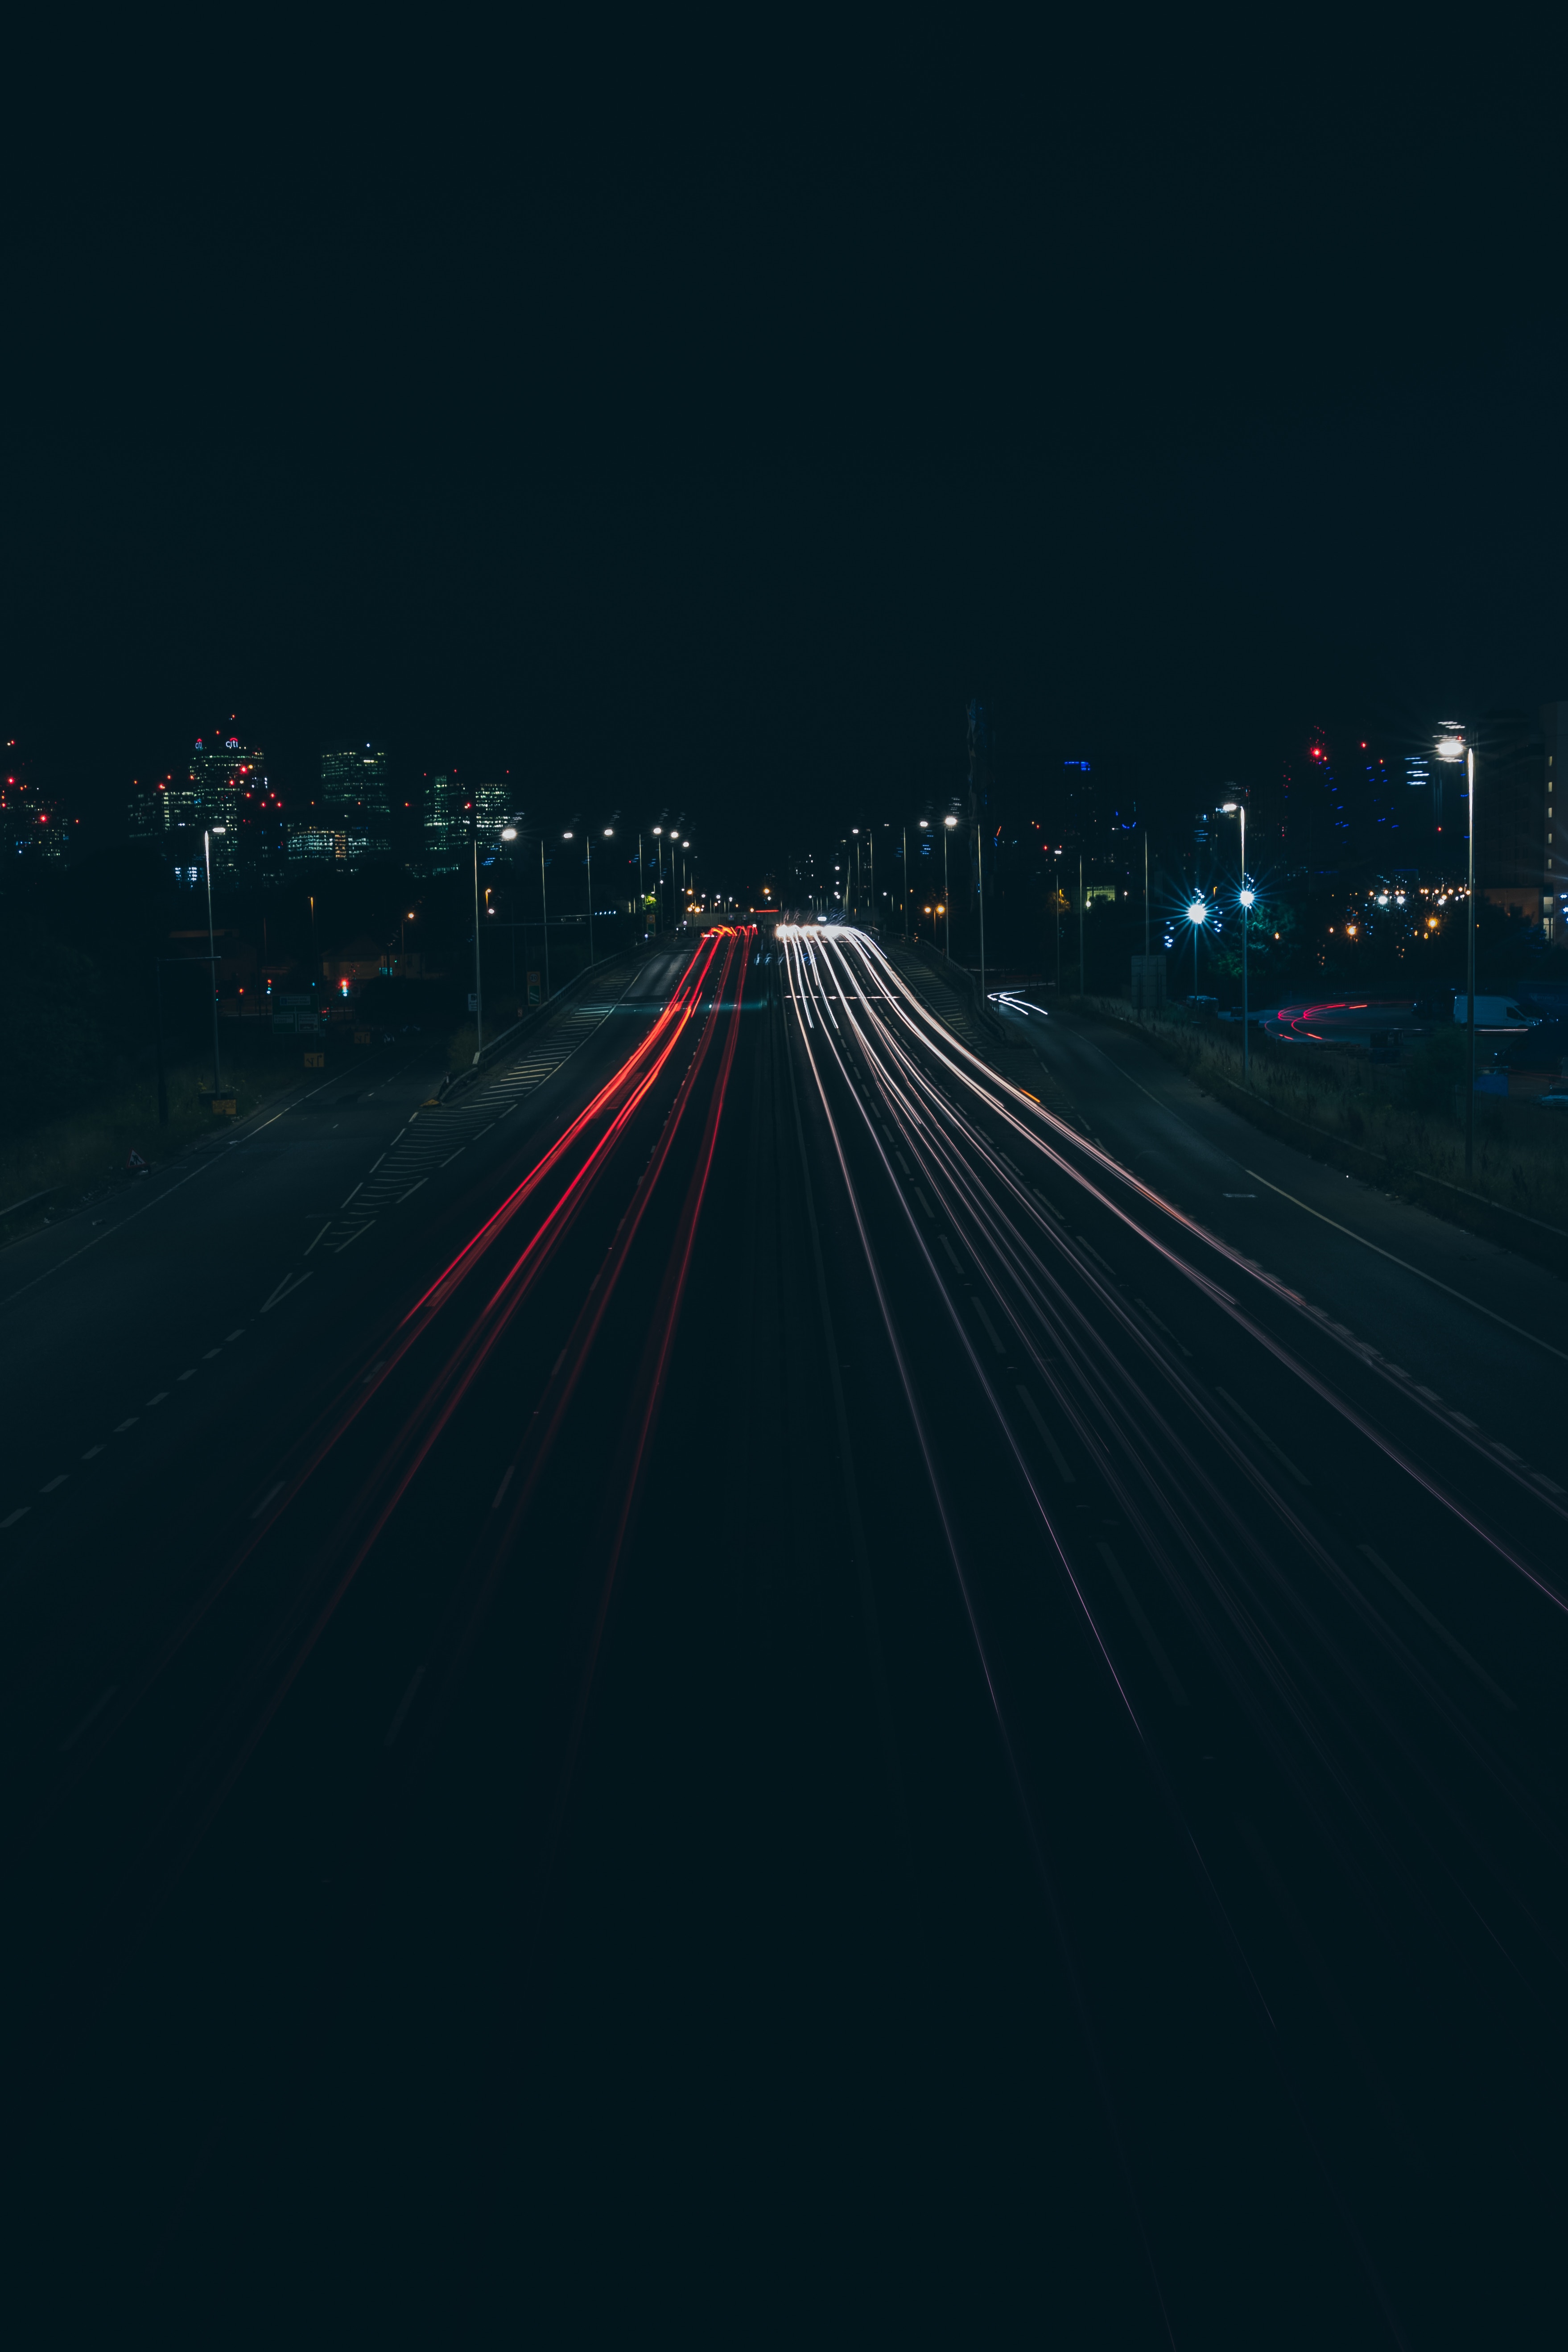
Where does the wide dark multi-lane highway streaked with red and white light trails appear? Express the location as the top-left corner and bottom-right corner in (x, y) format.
(0, 929), (1568, 2345)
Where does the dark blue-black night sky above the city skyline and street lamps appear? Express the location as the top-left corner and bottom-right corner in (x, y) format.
(0, 14), (1568, 873)
